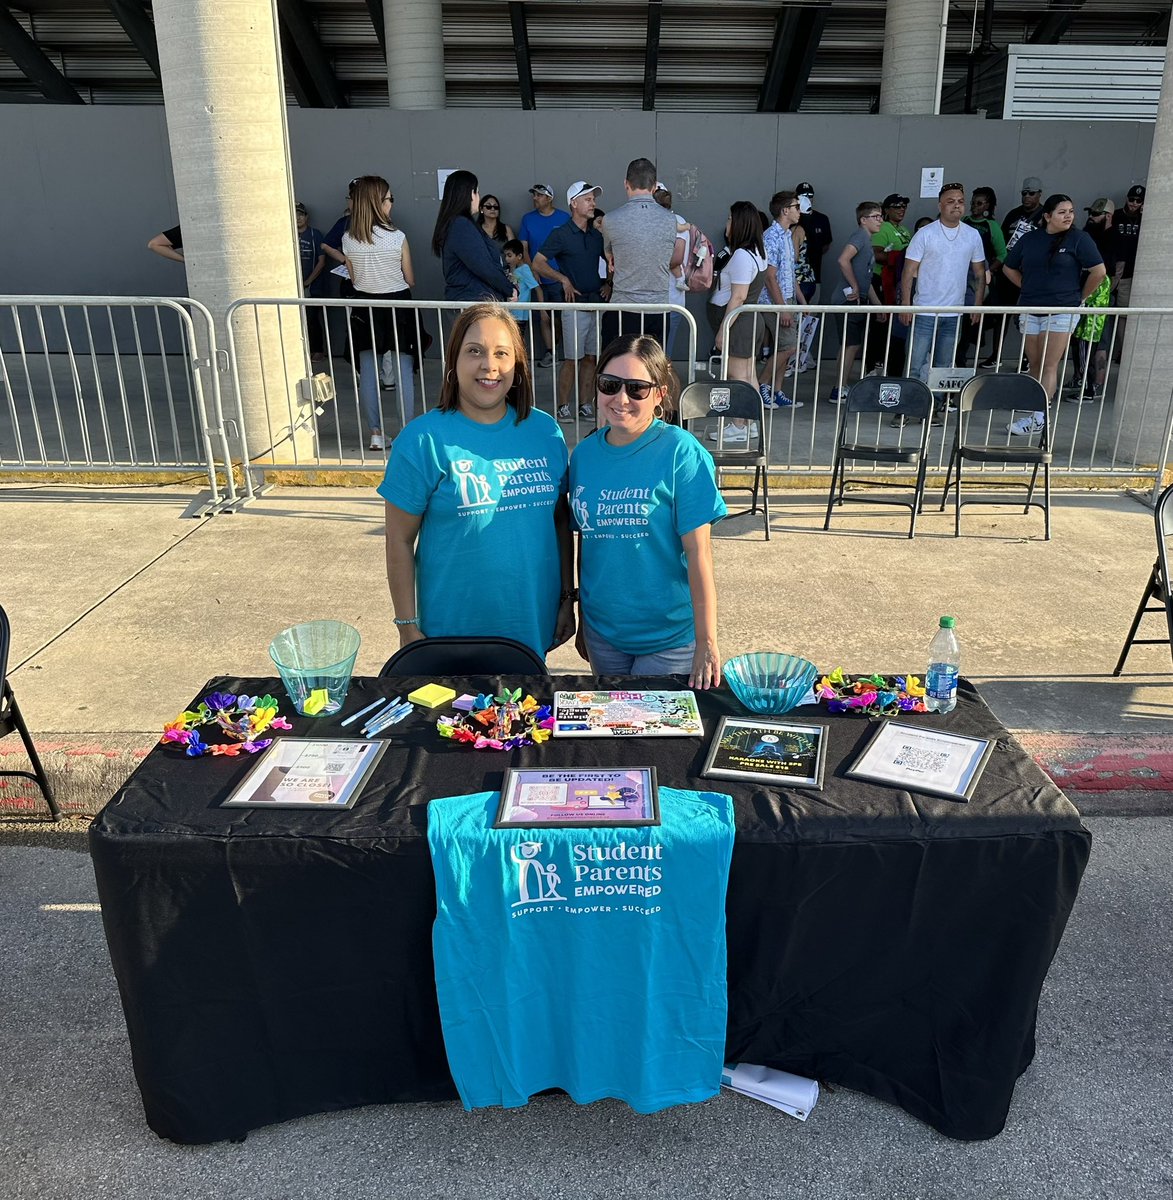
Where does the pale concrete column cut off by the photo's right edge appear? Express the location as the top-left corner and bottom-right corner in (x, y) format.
(1113, 46), (1173, 477)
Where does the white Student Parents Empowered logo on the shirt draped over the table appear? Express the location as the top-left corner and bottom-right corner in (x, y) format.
(510, 841), (663, 917)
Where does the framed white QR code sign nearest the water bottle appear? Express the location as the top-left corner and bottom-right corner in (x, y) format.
(846, 720), (994, 803)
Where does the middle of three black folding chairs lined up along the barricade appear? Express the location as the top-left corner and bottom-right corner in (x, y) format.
(823, 376), (933, 538)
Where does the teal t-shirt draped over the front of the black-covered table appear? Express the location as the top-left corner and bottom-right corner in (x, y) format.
(428, 787), (734, 1112)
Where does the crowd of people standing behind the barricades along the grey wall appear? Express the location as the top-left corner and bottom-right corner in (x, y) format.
(149, 158), (1145, 450)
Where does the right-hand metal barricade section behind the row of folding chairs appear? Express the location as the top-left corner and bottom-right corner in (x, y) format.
(710, 305), (1173, 490)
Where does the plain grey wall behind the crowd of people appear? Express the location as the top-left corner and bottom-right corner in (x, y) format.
(0, 104), (1153, 314)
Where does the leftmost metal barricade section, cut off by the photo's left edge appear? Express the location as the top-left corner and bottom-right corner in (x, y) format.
(0, 295), (235, 509)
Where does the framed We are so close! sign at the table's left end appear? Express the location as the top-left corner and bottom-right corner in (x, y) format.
(221, 738), (387, 810)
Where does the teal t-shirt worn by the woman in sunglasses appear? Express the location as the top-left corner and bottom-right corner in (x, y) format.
(570, 420), (728, 654)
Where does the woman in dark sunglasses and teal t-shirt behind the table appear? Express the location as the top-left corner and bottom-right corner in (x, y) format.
(570, 335), (727, 688)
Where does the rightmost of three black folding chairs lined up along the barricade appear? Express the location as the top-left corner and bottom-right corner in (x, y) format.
(940, 374), (1052, 541)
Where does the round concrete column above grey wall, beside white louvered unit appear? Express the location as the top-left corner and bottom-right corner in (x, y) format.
(879, 0), (949, 116)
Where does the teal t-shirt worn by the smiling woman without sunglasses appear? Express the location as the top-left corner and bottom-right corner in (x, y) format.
(379, 408), (566, 655)
